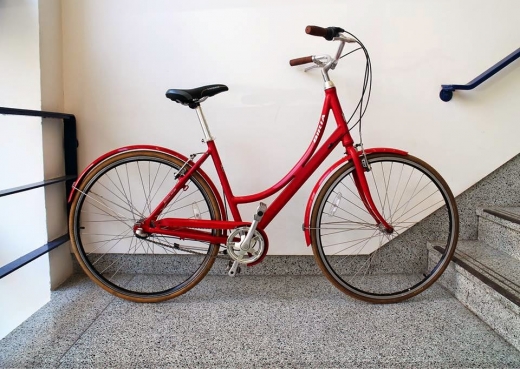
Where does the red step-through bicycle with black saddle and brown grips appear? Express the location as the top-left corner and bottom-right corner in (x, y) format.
(69, 26), (458, 303)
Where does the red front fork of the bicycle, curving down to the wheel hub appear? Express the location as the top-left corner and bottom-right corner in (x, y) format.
(347, 145), (394, 234)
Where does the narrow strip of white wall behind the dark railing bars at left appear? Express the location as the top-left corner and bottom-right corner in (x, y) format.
(0, 0), (50, 338)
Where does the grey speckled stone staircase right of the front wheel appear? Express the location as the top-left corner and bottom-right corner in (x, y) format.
(428, 204), (520, 350)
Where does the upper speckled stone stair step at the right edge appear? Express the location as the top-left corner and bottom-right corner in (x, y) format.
(477, 207), (520, 260)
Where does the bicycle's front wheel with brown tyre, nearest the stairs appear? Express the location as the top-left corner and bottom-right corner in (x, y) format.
(310, 153), (459, 303)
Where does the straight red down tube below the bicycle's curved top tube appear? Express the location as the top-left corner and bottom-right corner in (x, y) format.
(258, 126), (345, 229)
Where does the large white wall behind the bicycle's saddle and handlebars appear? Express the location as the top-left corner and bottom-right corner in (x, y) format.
(62, 0), (520, 254)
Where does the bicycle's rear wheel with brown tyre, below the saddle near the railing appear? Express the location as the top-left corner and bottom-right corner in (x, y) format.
(69, 151), (221, 302)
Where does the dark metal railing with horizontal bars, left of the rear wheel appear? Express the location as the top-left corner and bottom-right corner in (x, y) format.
(0, 107), (78, 279)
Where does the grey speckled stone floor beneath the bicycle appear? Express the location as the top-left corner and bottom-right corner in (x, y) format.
(0, 275), (520, 368)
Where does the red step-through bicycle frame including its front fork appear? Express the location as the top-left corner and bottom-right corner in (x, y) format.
(139, 87), (393, 244)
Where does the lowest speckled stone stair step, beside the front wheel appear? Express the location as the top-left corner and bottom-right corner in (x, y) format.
(428, 241), (520, 350)
